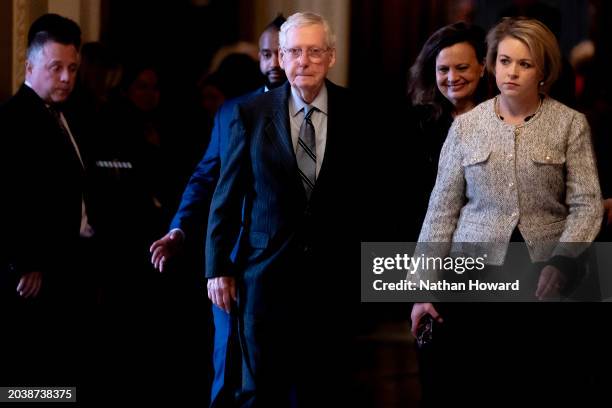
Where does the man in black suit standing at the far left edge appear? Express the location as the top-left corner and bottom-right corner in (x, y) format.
(0, 14), (93, 382)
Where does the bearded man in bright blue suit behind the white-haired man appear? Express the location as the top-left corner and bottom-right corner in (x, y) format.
(151, 16), (286, 407)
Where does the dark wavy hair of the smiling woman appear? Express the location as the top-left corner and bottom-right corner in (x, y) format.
(408, 22), (487, 119)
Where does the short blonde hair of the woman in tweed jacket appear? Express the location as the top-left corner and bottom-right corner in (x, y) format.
(487, 17), (561, 92)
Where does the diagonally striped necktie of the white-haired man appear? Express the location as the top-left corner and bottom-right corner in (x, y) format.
(295, 105), (317, 199)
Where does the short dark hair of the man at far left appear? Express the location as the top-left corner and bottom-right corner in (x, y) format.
(28, 13), (81, 56)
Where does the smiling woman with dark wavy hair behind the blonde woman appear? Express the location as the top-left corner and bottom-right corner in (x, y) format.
(408, 22), (488, 239)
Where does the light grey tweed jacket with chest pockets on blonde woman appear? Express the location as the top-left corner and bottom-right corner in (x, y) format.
(419, 97), (603, 265)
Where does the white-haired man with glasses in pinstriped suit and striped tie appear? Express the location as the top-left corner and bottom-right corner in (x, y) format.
(206, 13), (360, 407)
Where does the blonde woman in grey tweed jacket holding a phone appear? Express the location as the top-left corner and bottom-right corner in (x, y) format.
(411, 18), (603, 402)
